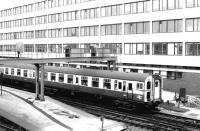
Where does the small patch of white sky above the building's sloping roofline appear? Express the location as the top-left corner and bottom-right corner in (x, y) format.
(0, 0), (41, 10)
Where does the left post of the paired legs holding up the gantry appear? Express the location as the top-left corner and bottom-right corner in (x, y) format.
(35, 64), (40, 100)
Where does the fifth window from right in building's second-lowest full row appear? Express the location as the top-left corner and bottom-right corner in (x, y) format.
(80, 25), (99, 36)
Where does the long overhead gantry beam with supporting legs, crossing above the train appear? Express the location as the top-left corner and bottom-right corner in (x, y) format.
(0, 57), (117, 101)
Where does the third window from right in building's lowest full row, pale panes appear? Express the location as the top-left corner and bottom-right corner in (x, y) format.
(124, 43), (150, 55)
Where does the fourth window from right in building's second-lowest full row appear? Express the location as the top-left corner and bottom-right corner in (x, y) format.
(101, 24), (122, 35)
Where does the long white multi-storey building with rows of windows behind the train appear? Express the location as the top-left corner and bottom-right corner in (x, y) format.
(0, 0), (200, 95)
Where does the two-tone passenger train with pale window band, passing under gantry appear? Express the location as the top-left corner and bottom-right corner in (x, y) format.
(0, 65), (163, 108)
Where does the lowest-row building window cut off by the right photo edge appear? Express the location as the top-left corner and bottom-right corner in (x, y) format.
(186, 42), (200, 56)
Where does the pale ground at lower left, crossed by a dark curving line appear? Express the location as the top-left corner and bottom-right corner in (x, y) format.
(0, 87), (126, 131)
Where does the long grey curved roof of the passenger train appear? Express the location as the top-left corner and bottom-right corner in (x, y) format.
(0, 64), (150, 82)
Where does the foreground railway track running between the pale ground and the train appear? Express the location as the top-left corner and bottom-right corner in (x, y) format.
(54, 97), (200, 131)
